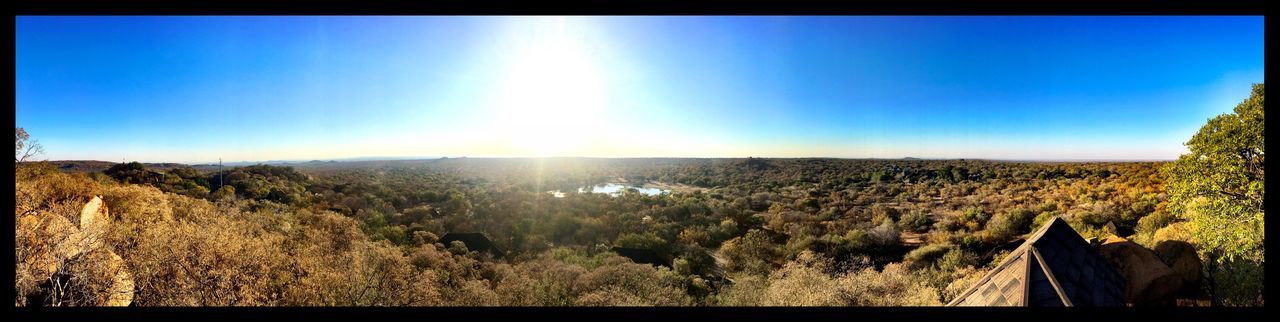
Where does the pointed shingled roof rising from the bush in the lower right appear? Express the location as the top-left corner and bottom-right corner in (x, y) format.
(947, 217), (1125, 307)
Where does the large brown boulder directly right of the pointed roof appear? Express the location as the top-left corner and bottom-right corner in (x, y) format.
(1098, 236), (1183, 305)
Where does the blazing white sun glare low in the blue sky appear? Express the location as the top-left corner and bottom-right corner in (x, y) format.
(497, 18), (605, 157)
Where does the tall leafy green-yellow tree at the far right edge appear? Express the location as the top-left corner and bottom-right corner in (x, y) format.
(1165, 84), (1266, 305)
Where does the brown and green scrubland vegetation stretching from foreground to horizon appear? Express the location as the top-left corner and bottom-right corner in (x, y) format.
(14, 86), (1263, 305)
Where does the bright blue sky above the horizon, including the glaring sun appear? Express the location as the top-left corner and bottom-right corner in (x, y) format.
(15, 17), (1263, 162)
